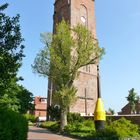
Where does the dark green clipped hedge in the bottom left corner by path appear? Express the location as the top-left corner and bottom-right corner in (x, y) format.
(0, 109), (28, 140)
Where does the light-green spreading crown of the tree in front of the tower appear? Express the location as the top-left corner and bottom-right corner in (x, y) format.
(32, 20), (104, 130)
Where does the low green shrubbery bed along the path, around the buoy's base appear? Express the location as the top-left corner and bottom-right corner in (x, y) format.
(40, 117), (140, 140)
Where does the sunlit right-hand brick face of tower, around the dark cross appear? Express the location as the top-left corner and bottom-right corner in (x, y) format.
(70, 0), (97, 115)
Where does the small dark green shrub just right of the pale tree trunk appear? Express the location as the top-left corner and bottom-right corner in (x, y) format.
(67, 113), (84, 124)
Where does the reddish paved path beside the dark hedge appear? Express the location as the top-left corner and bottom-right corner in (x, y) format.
(28, 126), (76, 140)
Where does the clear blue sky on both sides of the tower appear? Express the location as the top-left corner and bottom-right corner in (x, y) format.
(0, 0), (140, 112)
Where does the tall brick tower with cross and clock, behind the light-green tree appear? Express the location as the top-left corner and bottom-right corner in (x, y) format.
(48, 0), (97, 115)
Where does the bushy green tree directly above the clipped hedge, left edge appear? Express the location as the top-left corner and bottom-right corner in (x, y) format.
(0, 82), (34, 114)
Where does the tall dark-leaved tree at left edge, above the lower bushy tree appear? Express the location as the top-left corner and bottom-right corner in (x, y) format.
(0, 4), (24, 89)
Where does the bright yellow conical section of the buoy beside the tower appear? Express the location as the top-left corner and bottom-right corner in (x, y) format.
(94, 98), (106, 121)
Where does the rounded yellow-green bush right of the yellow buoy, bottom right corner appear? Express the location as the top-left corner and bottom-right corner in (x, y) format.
(93, 118), (139, 140)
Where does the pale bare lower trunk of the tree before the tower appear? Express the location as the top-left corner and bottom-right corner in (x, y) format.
(60, 110), (67, 131)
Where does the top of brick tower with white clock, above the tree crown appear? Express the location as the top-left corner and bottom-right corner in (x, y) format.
(54, 0), (96, 38)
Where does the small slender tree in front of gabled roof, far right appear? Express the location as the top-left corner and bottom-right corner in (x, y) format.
(126, 88), (137, 114)
